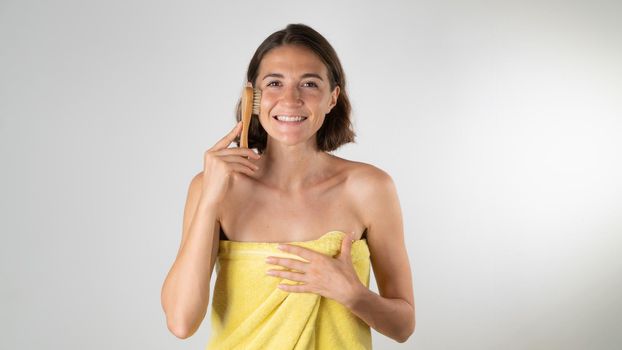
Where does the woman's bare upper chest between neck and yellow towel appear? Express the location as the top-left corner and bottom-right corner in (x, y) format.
(220, 176), (365, 242)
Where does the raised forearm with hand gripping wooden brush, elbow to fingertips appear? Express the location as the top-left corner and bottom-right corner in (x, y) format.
(161, 123), (259, 339)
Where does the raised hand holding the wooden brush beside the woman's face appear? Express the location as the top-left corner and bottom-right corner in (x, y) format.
(201, 122), (261, 205)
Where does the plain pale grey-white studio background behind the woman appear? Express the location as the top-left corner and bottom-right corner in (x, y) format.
(0, 0), (622, 350)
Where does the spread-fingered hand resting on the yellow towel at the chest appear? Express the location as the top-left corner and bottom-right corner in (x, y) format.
(266, 234), (365, 305)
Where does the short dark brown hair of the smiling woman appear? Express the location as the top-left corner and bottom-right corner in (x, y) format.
(235, 24), (356, 154)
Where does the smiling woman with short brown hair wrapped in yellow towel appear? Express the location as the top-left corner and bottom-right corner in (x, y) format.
(162, 24), (415, 349)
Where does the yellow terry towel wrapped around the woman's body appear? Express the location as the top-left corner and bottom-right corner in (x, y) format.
(207, 231), (371, 350)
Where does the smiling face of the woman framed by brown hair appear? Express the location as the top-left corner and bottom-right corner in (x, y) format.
(253, 45), (339, 147)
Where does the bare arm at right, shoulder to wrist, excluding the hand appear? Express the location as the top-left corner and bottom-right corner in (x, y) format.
(345, 167), (415, 343)
